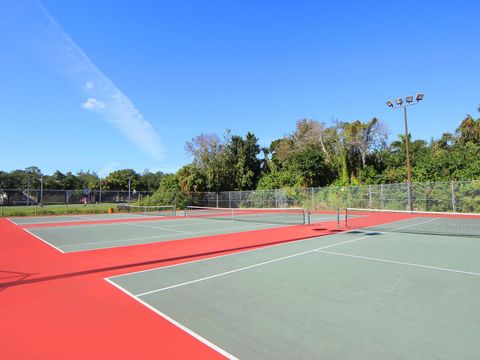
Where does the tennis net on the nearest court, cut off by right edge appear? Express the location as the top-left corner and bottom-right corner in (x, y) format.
(345, 208), (480, 237)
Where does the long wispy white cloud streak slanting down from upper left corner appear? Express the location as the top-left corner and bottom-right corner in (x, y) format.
(0, 0), (163, 160)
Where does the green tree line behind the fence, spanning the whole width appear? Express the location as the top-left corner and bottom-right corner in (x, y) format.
(0, 115), (480, 202)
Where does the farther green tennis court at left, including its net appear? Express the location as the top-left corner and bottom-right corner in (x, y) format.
(19, 207), (337, 252)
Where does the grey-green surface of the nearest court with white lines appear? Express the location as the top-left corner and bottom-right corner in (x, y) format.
(107, 221), (480, 360)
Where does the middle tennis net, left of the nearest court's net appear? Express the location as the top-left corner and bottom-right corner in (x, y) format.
(185, 206), (306, 225)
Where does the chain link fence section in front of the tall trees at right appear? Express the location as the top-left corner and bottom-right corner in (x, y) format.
(188, 180), (480, 213)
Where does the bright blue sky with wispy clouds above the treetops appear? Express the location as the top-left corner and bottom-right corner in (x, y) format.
(0, 0), (480, 175)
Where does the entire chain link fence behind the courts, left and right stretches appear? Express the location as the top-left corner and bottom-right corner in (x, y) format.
(0, 180), (480, 213)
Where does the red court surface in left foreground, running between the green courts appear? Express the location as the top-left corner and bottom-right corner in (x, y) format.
(0, 214), (354, 359)
